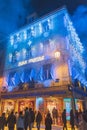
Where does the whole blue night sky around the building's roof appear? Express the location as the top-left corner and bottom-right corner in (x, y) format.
(0, 0), (87, 74)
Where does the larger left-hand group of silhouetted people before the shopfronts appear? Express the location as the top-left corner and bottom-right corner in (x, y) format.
(0, 107), (52, 130)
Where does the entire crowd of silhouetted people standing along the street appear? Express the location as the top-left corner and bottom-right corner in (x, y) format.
(0, 107), (87, 130)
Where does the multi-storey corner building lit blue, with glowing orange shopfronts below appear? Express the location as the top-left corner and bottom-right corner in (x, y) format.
(1, 8), (86, 119)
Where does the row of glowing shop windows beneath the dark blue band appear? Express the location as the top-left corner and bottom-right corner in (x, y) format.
(1, 91), (83, 125)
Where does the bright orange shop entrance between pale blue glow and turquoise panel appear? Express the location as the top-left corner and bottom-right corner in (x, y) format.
(45, 97), (63, 125)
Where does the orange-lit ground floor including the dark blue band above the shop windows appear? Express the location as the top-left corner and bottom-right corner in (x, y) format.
(0, 87), (84, 124)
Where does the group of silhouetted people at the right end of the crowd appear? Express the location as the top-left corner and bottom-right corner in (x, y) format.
(62, 109), (87, 130)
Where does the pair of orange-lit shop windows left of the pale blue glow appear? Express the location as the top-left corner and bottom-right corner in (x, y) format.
(1, 98), (35, 116)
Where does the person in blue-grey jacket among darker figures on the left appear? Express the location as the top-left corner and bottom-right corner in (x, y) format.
(17, 111), (24, 130)
